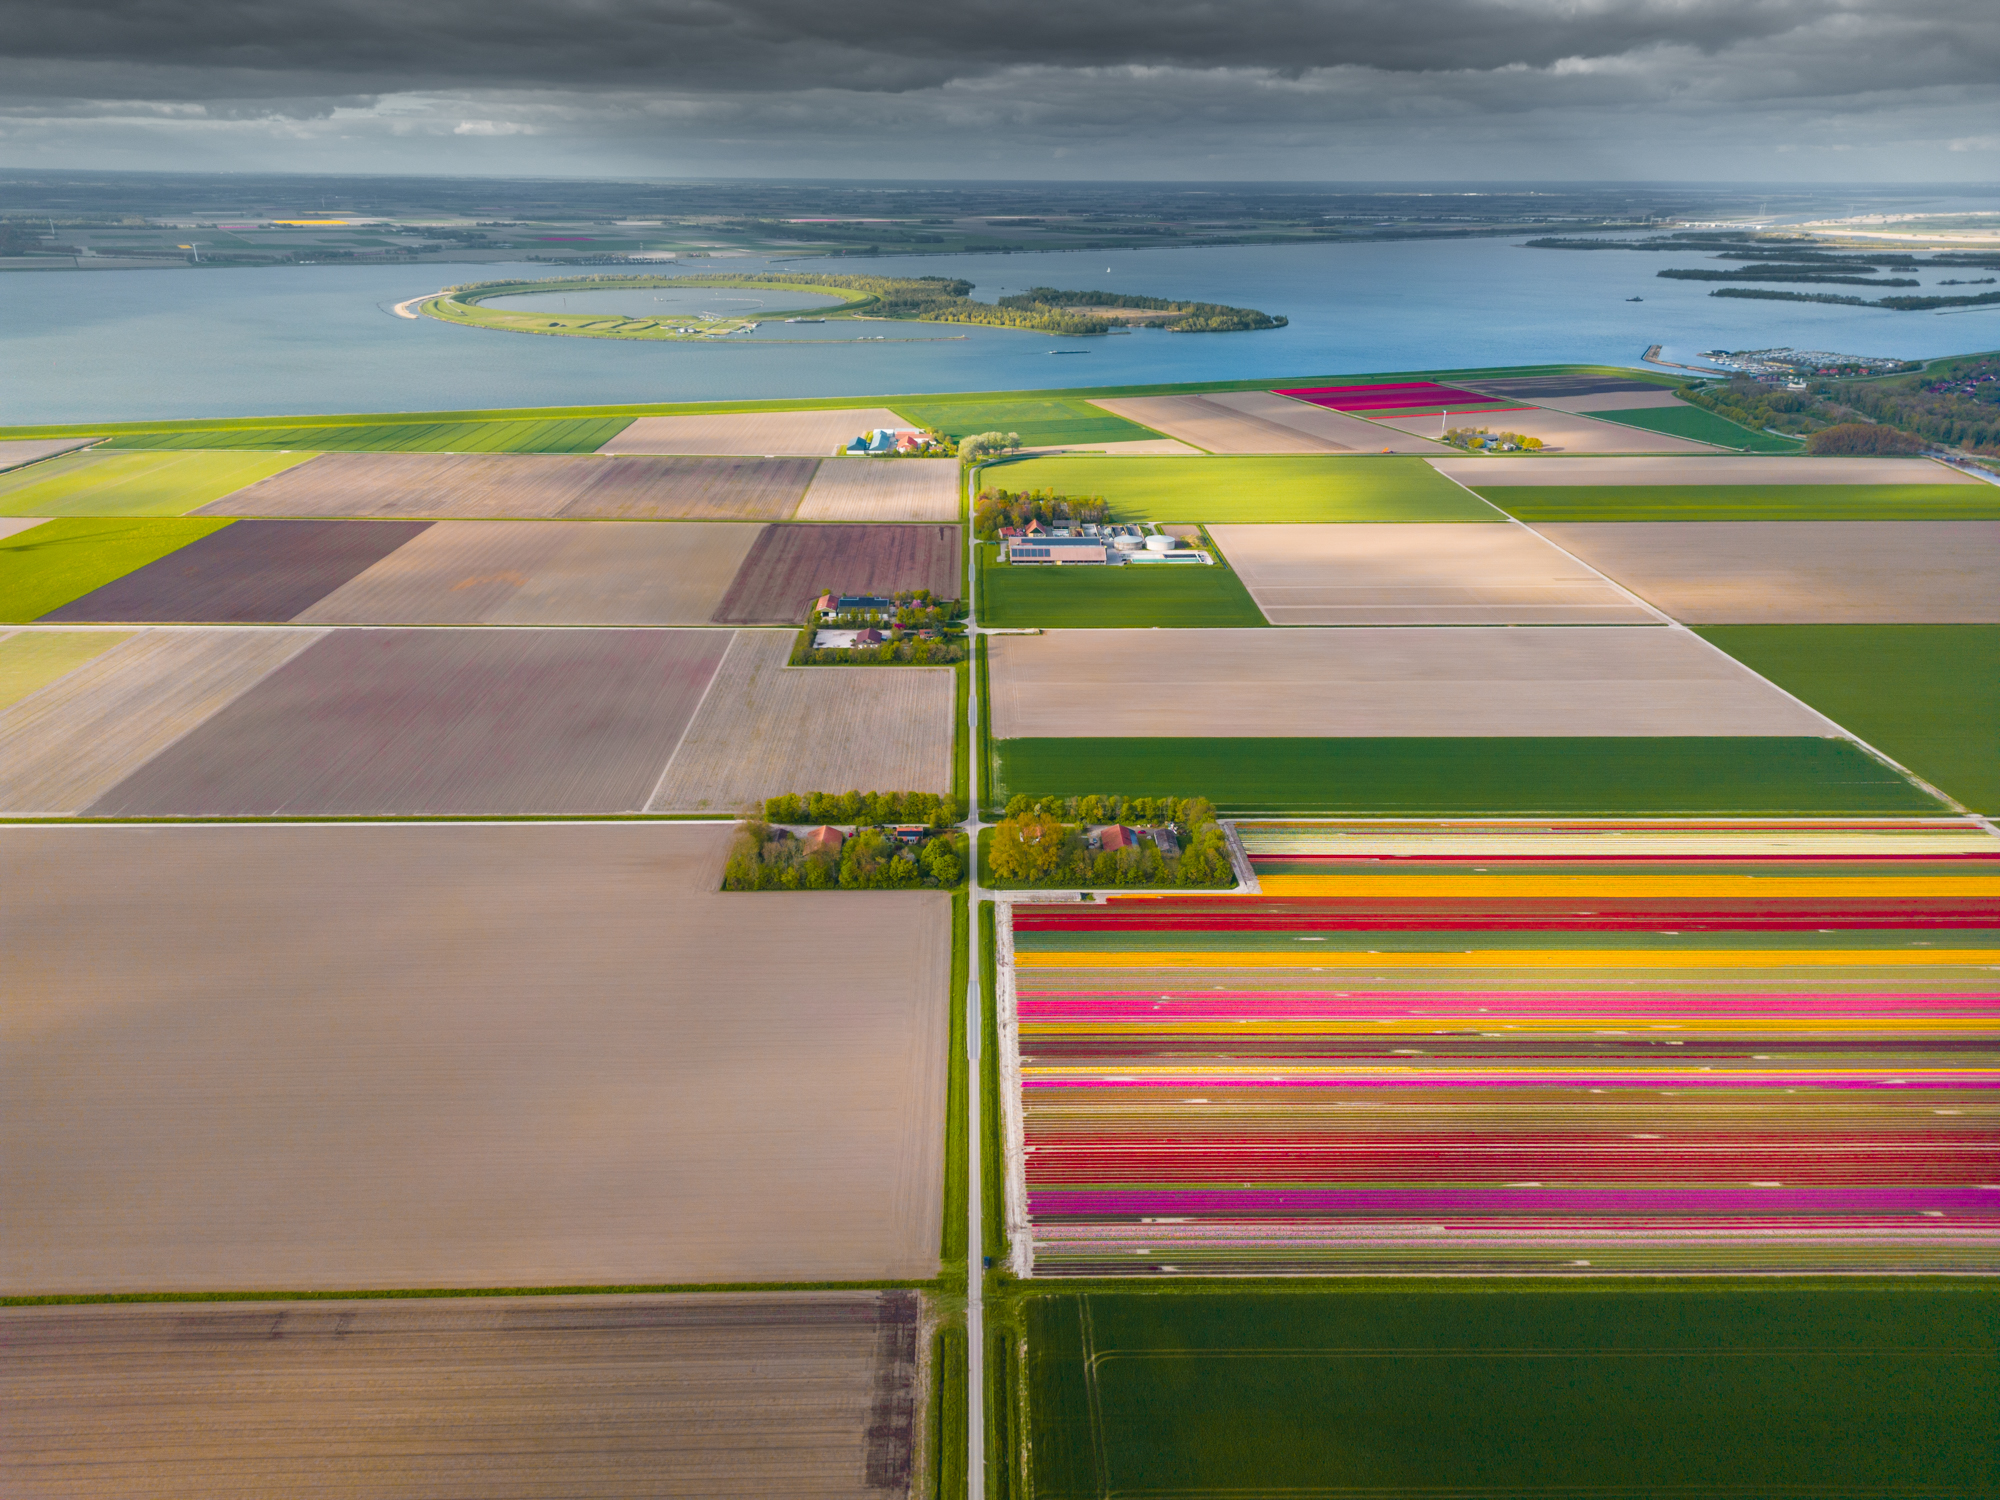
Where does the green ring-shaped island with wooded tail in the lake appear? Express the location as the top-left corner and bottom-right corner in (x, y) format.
(422, 270), (1284, 340)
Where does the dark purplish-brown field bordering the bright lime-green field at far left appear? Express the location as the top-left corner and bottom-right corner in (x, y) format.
(42, 520), (430, 624)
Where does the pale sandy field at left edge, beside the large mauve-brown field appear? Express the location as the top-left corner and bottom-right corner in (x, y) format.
(0, 630), (326, 816)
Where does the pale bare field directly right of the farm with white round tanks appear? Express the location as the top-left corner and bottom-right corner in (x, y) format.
(1208, 522), (1658, 626)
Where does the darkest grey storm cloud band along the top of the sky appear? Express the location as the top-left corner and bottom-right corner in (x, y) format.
(0, 0), (2000, 98)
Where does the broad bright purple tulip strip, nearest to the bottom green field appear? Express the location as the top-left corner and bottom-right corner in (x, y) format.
(1028, 1184), (2000, 1224)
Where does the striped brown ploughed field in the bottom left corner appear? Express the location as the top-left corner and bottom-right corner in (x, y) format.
(0, 1292), (922, 1500)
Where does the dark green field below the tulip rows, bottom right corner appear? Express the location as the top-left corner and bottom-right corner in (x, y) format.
(1020, 1282), (2000, 1500)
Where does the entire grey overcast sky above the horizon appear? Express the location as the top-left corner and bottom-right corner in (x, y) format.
(0, 0), (2000, 184)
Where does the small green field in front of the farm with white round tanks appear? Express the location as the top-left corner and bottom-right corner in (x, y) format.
(978, 546), (1264, 630)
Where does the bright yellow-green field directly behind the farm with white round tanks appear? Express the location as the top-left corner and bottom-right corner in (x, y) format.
(980, 454), (1500, 524)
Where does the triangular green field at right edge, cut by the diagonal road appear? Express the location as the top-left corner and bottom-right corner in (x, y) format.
(1698, 624), (2000, 814)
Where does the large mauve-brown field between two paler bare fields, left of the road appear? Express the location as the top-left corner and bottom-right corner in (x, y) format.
(84, 630), (730, 818)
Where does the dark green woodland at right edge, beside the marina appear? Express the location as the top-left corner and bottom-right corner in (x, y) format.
(1680, 354), (2000, 454)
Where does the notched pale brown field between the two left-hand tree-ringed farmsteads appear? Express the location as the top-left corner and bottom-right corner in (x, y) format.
(646, 630), (954, 812)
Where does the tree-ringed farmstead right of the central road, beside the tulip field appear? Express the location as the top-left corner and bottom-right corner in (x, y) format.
(980, 794), (1236, 890)
